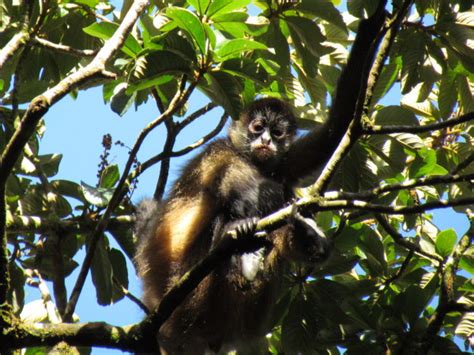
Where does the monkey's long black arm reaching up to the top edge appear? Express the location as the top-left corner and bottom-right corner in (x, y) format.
(282, 1), (385, 184)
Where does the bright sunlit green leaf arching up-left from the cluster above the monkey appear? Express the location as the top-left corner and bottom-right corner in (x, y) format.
(166, 7), (206, 54)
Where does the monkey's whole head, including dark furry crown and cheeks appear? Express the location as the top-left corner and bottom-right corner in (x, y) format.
(229, 98), (296, 168)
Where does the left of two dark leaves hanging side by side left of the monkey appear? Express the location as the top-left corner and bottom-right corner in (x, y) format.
(91, 235), (113, 306)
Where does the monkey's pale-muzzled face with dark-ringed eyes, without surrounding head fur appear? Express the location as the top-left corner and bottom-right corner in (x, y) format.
(247, 108), (294, 166)
